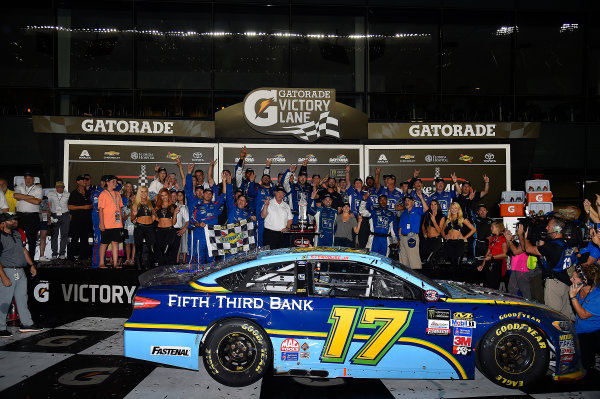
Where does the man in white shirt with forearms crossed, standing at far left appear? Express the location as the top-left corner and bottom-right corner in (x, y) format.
(14, 172), (43, 259)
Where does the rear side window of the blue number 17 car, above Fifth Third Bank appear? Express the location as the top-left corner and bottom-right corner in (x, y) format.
(217, 262), (296, 294)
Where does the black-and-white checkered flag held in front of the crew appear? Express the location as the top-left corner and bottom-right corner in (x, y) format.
(204, 219), (256, 257)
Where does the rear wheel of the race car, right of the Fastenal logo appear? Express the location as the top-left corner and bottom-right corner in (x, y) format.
(202, 319), (273, 387)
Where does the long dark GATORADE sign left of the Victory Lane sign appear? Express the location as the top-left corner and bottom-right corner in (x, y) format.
(32, 116), (215, 138)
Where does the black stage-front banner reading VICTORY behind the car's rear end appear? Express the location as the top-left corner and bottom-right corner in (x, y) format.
(28, 268), (139, 317)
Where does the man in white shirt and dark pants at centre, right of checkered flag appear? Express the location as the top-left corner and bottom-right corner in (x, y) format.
(260, 186), (294, 249)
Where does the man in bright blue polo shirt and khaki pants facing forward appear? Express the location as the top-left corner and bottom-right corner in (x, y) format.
(398, 192), (429, 269)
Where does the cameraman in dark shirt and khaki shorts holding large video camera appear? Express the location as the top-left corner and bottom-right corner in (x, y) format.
(525, 217), (576, 320)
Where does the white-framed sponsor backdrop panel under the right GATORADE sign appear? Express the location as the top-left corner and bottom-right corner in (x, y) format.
(365, 144), (510, 210)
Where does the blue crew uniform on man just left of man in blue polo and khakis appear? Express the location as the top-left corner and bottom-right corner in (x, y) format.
(360, 198), (396, 256)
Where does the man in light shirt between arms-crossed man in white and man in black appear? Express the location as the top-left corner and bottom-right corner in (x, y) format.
(48, 181), (71, 259)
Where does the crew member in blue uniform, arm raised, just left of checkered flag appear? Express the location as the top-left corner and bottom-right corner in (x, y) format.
(185, 174), (225, 263)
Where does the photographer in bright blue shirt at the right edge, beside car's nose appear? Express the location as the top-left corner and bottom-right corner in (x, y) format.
(569, 265), (600, 370)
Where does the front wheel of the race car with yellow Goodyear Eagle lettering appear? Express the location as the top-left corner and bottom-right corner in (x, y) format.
(477, 320), (550, 389)
